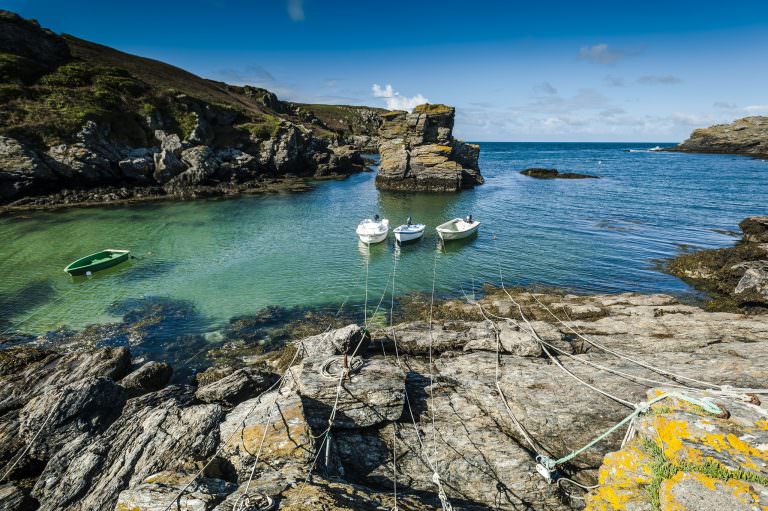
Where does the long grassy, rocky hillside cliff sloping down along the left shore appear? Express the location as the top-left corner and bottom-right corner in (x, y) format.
(0, 11), (380, 206)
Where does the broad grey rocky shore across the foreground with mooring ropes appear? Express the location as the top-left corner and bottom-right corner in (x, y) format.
(0, 290), (768, 511)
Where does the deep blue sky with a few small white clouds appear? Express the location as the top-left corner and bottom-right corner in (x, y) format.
(0, 0), (768, 142)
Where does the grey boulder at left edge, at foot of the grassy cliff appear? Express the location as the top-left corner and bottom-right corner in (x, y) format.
(0, 136), (57, 200)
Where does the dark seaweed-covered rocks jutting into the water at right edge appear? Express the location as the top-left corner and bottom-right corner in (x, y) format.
(668, 216), (768, 312)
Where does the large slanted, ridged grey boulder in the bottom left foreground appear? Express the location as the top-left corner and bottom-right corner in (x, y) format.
(32, 386), (222, 511)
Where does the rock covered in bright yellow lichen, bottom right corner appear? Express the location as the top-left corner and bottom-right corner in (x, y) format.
(586, 389), (768, 511)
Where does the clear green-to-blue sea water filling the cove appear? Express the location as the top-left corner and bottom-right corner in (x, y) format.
(0, 143), (768, 332)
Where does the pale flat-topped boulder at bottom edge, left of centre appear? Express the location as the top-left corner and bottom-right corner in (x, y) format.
(115, 471), (237, 511)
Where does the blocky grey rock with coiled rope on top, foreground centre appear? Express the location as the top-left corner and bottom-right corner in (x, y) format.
(294, 358), (405, 430)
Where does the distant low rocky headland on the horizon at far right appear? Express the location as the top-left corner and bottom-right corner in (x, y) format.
(670, 116), (768, 157)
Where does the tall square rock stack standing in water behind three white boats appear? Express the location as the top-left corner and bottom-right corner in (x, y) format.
(376, 104), (483, 192)
